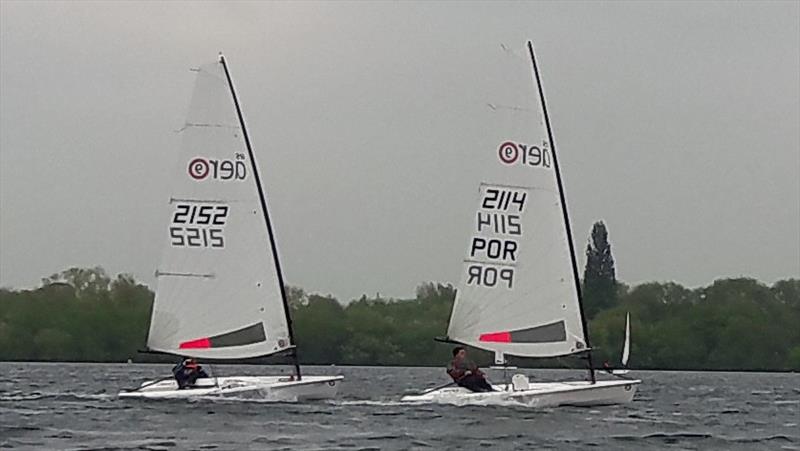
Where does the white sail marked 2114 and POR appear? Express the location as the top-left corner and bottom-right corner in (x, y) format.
(448, 44), (586, 358)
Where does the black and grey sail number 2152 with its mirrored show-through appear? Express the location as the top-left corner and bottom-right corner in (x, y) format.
(169, 203), (230, 248)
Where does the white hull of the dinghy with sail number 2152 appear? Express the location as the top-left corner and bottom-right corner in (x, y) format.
(119, 376), (344, 402)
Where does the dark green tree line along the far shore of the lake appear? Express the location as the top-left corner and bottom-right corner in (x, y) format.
(0, 222), (800, 370)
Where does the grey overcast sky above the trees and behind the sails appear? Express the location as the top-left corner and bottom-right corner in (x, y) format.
(0, 0), (800, 301)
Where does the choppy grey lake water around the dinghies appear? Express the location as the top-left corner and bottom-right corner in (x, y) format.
(0, 363), (800, 450)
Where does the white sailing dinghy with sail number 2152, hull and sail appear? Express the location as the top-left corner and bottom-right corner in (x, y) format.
(119, 55), (343, 401)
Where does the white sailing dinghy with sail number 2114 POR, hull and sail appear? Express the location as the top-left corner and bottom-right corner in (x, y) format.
(402, 41), (640, 407)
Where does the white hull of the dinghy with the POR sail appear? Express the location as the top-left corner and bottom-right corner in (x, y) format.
(401, 380), (641, 408)
